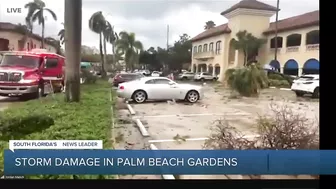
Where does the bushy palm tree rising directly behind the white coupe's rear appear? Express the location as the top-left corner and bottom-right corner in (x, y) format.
(116, 31), (143, 71)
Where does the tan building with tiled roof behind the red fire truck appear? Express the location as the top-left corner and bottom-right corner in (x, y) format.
(0, 22), (57, 53)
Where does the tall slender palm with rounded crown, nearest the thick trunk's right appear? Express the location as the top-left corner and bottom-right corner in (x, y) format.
(89, 11), (106, 77)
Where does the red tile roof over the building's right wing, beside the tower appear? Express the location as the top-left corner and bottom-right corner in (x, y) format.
(264, 10), (320, 34)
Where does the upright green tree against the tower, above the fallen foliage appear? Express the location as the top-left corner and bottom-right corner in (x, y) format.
(232, 30), (266, 66)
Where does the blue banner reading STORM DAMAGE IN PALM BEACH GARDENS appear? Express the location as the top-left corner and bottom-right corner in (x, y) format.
(4, 150), (336, 175)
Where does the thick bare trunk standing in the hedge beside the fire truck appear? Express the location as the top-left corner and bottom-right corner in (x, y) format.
(64, 0), (82, 102)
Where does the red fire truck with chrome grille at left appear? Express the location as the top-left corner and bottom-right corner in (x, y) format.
(0, 49), (65, 98)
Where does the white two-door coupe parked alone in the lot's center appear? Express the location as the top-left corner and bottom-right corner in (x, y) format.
(117, 77), (203, 103)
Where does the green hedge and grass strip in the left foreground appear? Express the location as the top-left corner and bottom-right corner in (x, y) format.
(0, 80), (114, 179)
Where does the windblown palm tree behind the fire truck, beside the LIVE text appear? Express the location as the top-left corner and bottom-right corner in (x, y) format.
(25, 0), (57, 48)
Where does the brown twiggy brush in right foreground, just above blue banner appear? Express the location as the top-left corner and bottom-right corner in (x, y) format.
(204, 104), (319, 150)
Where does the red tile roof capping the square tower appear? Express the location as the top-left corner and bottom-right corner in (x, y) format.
(221, 0), (277, 15)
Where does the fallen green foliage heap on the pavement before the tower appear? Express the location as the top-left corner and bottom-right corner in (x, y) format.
(225, 64), (268, 96)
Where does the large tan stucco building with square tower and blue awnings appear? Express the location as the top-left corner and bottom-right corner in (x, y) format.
(191, 0), (319, 81)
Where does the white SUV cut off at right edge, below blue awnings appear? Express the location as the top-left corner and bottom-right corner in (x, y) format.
(291, 74), (320, 98)
